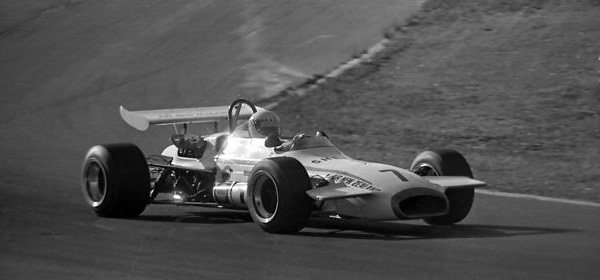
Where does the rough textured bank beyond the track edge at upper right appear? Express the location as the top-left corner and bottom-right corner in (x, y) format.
(276, 0), (600, 202)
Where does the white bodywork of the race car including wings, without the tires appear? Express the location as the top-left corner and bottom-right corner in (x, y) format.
(121, 100), (485, 220)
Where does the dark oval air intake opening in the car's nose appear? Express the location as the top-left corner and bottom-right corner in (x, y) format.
(391, 188), (448, 220)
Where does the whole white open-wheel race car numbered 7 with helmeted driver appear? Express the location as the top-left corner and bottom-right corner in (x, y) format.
(82, 99), (485, 233)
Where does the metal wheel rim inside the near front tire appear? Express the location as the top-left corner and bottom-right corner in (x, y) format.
(252, 173), (279, 223)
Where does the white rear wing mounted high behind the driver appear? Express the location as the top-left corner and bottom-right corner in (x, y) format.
(119, 106), (262, 131)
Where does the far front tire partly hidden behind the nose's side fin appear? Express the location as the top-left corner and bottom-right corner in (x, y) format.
(411, 150), (475, 225)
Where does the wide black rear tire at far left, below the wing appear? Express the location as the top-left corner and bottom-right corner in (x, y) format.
(82, 144), (150, 218)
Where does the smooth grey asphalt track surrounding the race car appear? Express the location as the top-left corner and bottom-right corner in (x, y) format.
(0, 1), (600, 279)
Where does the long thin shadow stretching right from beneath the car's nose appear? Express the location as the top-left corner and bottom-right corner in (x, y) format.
(298, 218), (579, 240)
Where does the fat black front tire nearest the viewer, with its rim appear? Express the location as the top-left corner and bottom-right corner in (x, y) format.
(246, 157), (313, 234)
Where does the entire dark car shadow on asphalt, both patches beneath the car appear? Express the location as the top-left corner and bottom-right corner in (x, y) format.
(137, 209), (580, 240)
